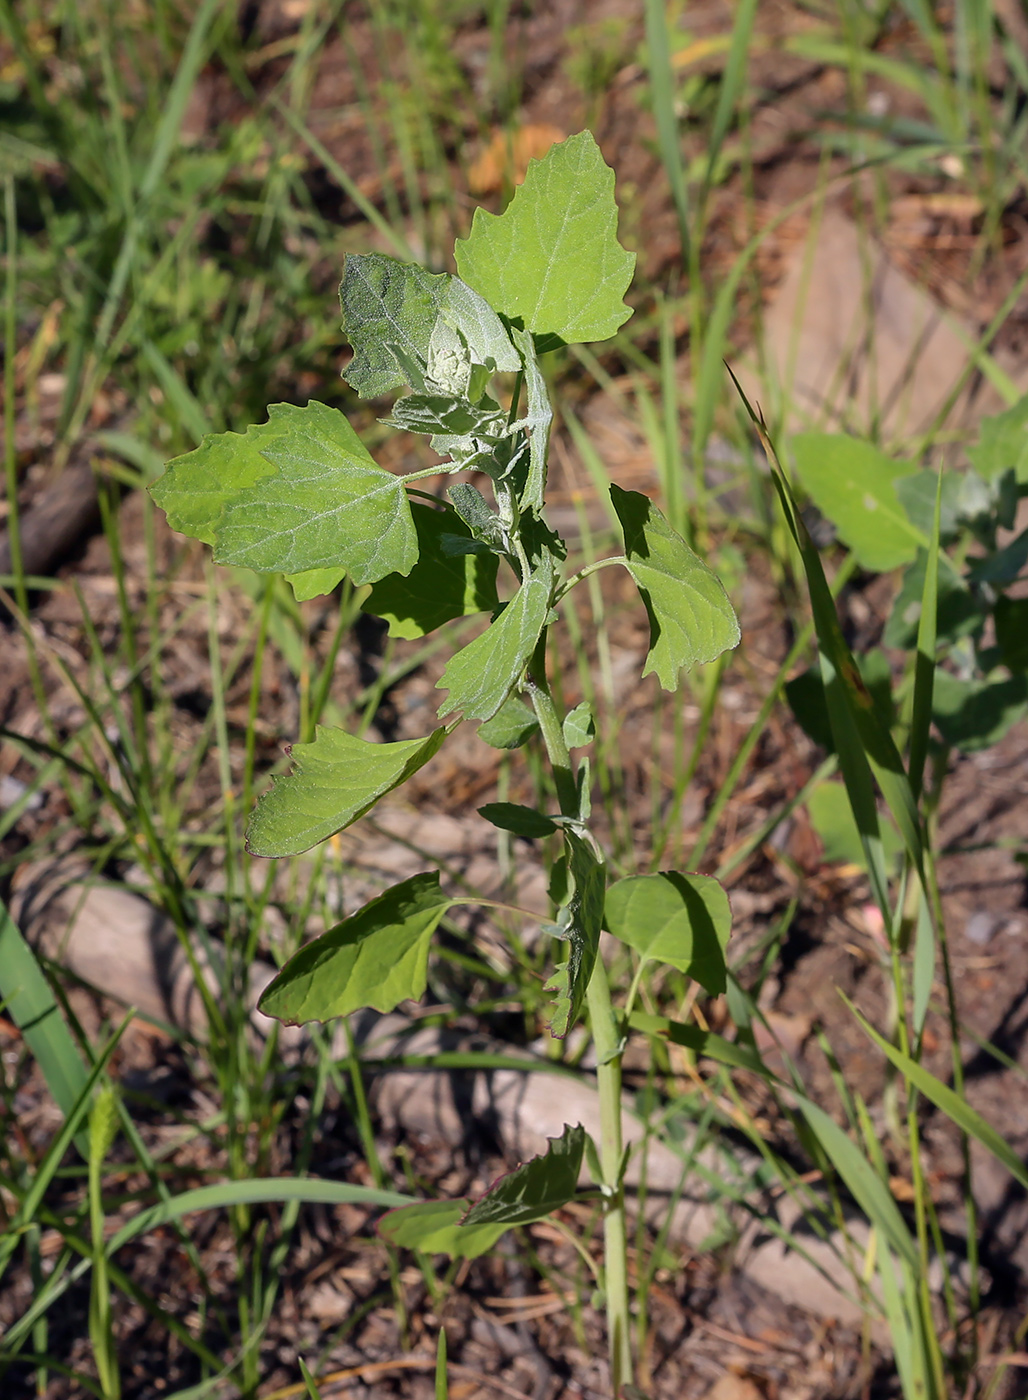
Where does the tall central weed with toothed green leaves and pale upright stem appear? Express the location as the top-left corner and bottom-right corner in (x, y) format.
(153, 132), (739, 1389)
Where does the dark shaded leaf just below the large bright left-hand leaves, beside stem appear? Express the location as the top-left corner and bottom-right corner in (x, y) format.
(361, 501), (499, 637)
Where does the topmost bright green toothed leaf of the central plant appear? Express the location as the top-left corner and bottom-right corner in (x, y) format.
(454, 132), (636, 344)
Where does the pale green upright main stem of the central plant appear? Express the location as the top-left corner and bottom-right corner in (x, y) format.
(528, 631), (632, 1397)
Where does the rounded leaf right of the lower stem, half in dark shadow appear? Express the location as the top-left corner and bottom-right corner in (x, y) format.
(604, 871), (731, 995)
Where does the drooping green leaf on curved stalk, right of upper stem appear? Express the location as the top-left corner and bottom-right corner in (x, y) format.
(611, 486), (739, 690)
